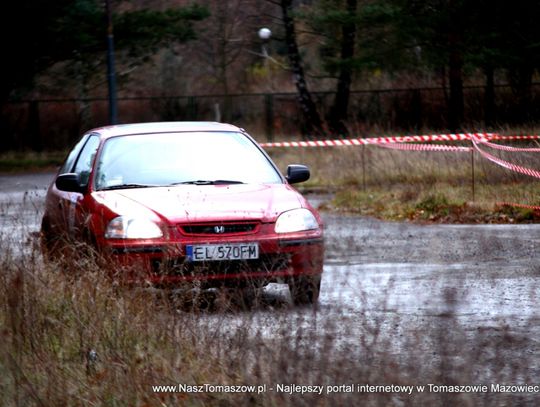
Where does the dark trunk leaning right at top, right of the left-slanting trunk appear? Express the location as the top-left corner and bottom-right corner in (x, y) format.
(328, 0), (358, 137)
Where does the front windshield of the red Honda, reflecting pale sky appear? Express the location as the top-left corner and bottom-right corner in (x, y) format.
(95, 132), (282, 190)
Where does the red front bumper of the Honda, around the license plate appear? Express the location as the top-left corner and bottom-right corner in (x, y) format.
(99, 233), (324, 287)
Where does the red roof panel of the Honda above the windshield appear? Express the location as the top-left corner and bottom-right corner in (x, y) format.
(86, 121), (244, 138)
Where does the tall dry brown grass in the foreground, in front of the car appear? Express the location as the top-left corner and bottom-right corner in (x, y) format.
(0, 237), (534, 406)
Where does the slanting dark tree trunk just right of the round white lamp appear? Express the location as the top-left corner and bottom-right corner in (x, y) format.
(280, 0), (323, 136)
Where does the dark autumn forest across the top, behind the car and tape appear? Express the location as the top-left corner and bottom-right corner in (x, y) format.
(0, 0), (540, 151)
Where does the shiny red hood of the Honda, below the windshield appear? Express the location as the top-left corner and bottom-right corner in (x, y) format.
(93, 184), (308, 223)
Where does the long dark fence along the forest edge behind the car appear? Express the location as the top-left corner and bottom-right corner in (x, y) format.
(0, 84), (540, 151)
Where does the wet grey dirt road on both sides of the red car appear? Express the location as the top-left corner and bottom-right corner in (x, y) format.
(0, 174), (540, 405)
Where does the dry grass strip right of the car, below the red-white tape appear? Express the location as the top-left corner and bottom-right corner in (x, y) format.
(270, 139), (540, 223)
